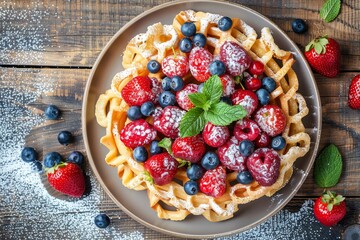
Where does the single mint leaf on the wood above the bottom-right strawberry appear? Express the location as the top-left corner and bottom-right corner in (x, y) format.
(314, 144), (342, 188)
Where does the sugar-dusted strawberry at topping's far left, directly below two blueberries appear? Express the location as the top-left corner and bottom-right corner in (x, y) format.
(120, 119), (156, 148)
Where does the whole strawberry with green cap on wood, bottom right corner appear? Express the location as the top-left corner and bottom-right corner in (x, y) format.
(314, 191), (346, 227)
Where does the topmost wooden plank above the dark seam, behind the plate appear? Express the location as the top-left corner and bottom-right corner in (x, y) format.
(0, 0), (360, 71)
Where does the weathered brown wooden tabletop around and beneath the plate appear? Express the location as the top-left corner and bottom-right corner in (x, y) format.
(0, 0), (360, 239)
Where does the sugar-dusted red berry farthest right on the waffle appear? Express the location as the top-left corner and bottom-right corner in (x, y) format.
(254, 105), (286, 137)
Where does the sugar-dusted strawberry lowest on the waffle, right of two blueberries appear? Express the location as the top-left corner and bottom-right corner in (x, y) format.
(200, 165), (226, 198)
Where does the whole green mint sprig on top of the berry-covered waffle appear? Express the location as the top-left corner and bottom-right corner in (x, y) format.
(180, 75), (247, 137)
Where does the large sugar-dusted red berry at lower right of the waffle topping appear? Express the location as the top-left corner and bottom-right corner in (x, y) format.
(246, 148), (280, 186)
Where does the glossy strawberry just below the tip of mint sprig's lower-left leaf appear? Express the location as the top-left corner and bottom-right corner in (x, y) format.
(171, 135), (206, 163)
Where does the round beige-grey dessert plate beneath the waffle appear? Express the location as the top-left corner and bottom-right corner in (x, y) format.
(82, 0), (321, 238)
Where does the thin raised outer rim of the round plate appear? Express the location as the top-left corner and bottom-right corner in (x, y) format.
(81, 0), (322, 238)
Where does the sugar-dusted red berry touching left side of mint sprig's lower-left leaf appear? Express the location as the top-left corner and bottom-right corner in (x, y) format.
(154, 106), (186, 138)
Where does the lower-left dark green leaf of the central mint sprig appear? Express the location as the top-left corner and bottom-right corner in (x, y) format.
(180, 107), (206, 137)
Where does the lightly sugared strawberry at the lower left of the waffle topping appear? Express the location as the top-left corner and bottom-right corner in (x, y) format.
(144, 153), (179, 185)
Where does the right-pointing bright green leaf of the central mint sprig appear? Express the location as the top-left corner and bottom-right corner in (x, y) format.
(205, 102), (247, 126)
